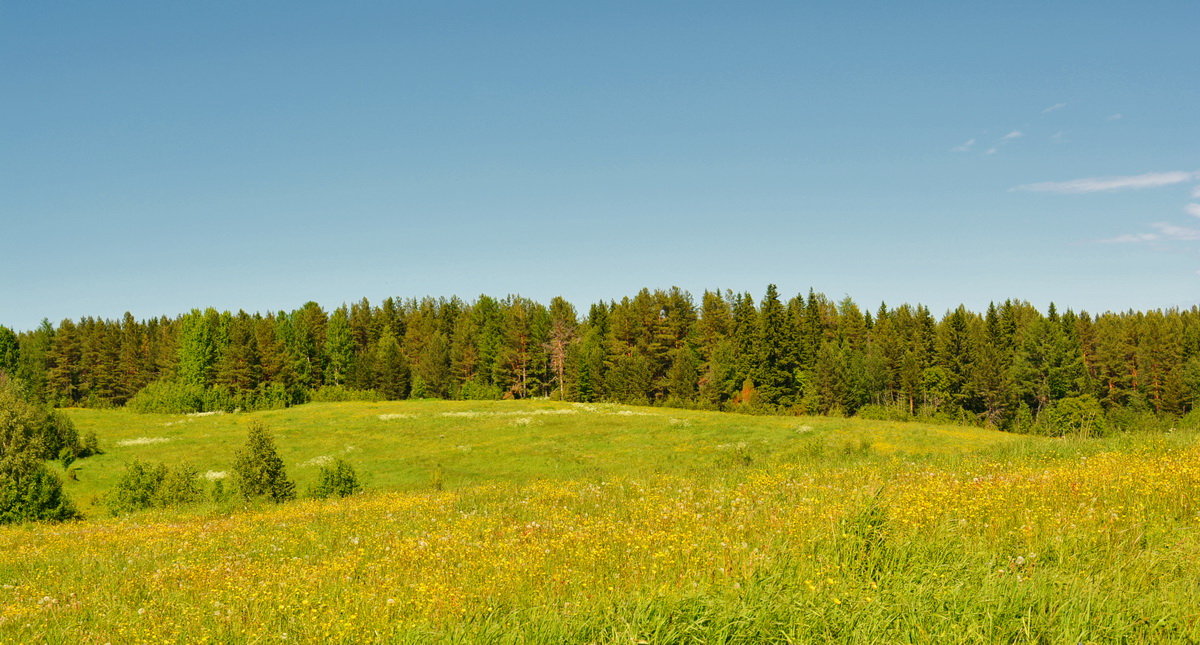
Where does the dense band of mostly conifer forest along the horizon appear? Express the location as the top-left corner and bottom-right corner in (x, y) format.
(0, 285), (1200, 434)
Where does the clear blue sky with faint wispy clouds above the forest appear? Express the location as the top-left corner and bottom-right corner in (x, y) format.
(0, 0), (1200, 328)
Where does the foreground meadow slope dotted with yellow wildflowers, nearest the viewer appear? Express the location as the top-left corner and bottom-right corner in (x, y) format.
(0, 433), (1200, 643)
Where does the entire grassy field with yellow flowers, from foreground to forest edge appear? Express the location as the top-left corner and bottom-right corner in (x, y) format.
(0, 402), (1200, 644)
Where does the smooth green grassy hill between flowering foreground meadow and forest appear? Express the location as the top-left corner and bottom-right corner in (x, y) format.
(67, 400), (1036, 514)
